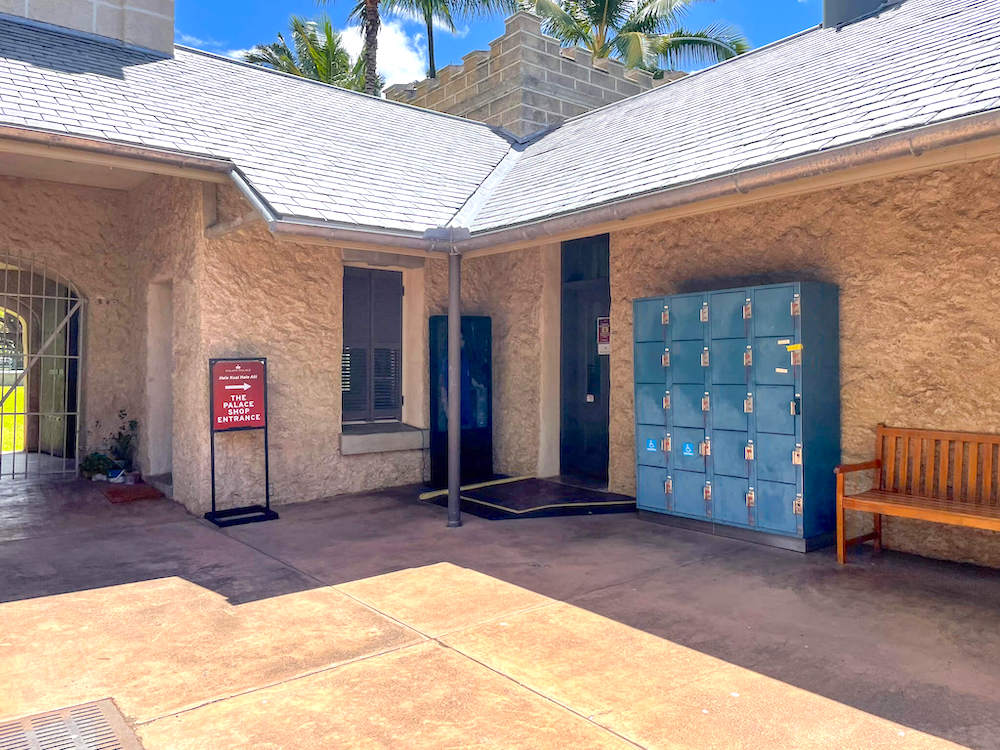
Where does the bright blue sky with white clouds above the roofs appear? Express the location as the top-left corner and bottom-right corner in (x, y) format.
(176, 0), (822, 84)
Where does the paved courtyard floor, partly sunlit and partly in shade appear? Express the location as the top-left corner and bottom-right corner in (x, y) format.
(0, 483), (1000, 750)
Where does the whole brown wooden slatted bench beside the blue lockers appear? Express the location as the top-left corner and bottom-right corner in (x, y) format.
(834, 424), (1000, 564)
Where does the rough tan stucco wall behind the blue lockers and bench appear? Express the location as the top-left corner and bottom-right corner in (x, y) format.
(610, 161), (1000, 566)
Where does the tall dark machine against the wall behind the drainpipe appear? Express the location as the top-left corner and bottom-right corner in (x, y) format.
(430, 315), (493, 487)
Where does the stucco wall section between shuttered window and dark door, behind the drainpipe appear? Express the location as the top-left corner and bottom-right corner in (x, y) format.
(427, 249), (544, 475)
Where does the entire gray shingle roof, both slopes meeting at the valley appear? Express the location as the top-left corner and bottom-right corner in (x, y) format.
(0, 0), (1000, 238)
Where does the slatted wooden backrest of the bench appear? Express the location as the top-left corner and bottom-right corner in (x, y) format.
(875, 425), (1000, 505)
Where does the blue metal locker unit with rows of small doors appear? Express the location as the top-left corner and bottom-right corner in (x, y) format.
(634, 282), (840, 551)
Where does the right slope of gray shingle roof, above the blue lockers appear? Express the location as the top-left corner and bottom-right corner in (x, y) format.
(471, 0), (1000, 232)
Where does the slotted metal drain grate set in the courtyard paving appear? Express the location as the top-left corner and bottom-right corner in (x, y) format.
(0, 698), (142, 750)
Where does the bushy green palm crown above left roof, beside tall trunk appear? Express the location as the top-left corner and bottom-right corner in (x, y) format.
(243, 16), (382, 93)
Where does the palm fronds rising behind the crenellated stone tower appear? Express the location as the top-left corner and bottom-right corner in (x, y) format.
(525, 0), (750, 72)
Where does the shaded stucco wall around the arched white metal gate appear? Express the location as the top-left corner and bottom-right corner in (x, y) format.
(0, 177), (142, 455)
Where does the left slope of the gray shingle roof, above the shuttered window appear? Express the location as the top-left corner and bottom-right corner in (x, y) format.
(0, 19), (509, 232)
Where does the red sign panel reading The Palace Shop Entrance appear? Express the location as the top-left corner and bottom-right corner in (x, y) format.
(211, 359), (267, 432)
